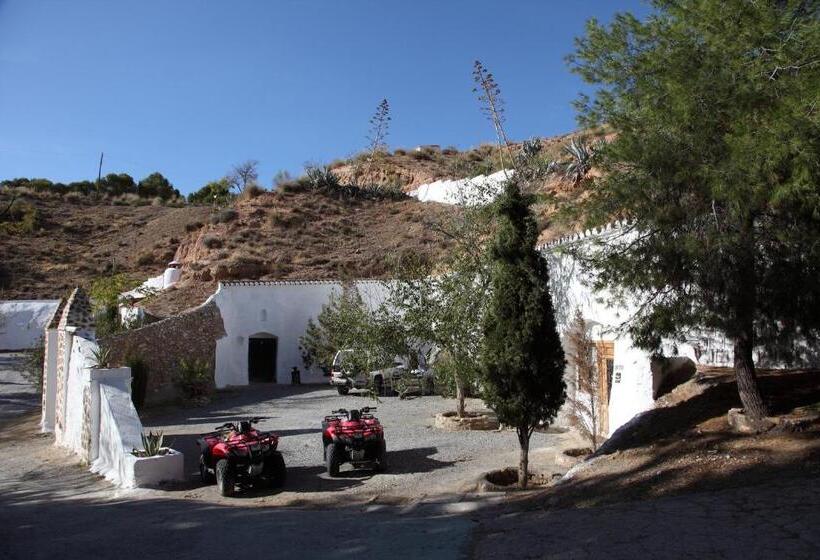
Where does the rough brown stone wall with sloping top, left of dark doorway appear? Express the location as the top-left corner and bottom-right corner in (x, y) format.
(106, 303), (225, 405)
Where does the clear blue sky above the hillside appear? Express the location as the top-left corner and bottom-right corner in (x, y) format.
(0, 0), (647, 193)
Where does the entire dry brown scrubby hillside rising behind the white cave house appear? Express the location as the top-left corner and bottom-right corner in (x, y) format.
(0, 135), (584, 316)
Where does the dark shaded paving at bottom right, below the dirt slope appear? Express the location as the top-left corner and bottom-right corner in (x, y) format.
(473, 476), (820, 560)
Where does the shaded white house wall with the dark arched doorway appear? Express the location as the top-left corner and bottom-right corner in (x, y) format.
(209, 281), (386, 388)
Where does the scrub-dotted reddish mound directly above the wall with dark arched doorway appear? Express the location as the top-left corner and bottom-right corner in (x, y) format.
(146, 187), (458, 316)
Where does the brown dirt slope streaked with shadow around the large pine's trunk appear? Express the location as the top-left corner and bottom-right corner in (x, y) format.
(538, 369), (820, 508)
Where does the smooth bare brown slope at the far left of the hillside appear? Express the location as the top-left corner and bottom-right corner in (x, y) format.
(0, 190), (211, 299)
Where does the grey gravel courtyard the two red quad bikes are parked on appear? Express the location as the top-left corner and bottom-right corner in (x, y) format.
(143, 384), (577, 505)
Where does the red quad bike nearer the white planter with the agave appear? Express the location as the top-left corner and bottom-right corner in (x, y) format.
(196, 418), (286, 496)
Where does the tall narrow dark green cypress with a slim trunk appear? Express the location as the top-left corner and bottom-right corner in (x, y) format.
(482, 180), (566, 488)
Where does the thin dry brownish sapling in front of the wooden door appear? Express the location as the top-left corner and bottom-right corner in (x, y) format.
(568, 309), (601, 451)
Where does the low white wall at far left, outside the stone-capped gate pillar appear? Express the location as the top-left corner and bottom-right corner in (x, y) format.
(0, 299), (60, 350)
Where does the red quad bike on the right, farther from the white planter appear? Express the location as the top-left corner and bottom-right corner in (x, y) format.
(322, 407), (387, 476)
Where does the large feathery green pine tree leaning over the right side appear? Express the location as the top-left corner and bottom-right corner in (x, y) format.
(569, 0), (820, 419)
